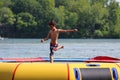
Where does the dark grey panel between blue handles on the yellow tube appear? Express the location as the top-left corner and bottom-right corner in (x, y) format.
(80, 68), (112, 80)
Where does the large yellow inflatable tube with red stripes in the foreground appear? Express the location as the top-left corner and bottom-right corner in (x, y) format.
(0, 63), (120, 80)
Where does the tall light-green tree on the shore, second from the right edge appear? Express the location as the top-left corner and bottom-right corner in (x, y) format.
(90, 2), (108, 37)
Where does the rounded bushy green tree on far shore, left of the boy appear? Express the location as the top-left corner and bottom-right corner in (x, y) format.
(16, 12), (37, 37)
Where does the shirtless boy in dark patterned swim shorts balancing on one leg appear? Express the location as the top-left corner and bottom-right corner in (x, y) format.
(41, 21), (78, 63)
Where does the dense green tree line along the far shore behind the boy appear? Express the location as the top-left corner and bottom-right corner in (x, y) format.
(0, 0), (120, 38)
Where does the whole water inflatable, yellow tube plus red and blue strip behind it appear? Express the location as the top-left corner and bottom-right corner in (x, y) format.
(0, 56), (120, 80)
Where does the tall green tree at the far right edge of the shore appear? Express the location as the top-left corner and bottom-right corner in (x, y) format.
(108, 0), (120, 37)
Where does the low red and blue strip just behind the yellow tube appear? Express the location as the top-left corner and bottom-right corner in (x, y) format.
(0, 56), (120, 63)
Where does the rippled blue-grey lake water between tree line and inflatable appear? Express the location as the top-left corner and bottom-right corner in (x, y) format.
(0, 39), (120, 58)
